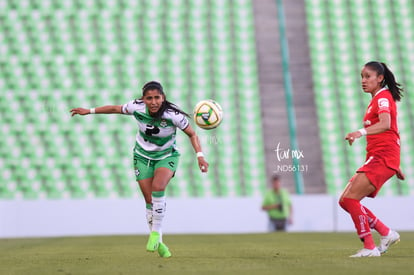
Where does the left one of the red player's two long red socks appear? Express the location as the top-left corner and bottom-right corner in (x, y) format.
(339, 198), (375, 249)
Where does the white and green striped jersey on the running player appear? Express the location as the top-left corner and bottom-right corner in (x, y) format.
(122, 100), (189, 160)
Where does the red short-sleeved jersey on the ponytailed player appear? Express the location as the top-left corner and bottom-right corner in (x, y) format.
(364, 88), (400, 171)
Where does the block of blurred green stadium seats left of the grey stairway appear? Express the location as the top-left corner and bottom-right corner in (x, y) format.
(0, 0), (265, 199)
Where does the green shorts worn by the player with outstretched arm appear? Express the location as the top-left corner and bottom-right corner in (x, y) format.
(134, 151), (180, 181)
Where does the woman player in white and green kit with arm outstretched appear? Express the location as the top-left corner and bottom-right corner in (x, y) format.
(71, 81), (208, 258)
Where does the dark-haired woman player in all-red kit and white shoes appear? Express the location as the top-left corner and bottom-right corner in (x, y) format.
(339, 61), (404, 257)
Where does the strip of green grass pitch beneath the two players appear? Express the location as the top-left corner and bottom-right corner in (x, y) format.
(0, 232), (414, 275)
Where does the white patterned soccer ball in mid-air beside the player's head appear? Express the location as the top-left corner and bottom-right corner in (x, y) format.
(193, 99), (223, 130)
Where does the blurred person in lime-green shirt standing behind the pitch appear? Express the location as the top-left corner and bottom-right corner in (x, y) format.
(262, 174), (292, 231)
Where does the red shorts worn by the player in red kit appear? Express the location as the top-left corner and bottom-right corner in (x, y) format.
(357, 156), (397, 198)
